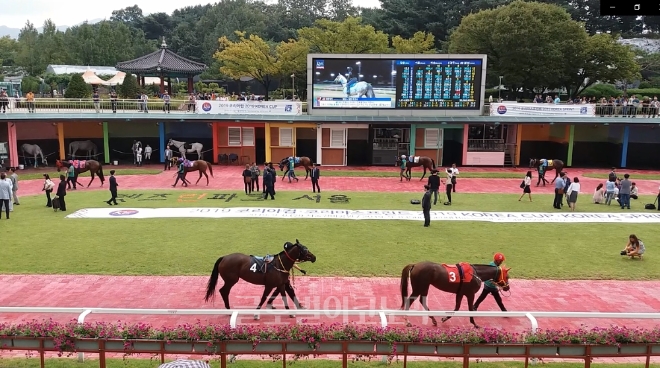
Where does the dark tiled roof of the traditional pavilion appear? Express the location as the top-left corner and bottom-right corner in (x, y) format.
(116, 39), (207, 75)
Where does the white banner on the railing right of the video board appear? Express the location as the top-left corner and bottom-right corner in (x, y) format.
(490, 102), (596, 118)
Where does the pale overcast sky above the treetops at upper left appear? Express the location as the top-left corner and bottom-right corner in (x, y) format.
(0, 0), (379, 28)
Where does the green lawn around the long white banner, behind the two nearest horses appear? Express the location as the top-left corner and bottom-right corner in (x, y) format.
(0, 190), (660, 280)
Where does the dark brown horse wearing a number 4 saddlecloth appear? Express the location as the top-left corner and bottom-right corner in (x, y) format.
(204, 239), (316, 319)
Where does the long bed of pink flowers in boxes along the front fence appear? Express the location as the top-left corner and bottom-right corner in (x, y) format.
(0, 320), (660, 356)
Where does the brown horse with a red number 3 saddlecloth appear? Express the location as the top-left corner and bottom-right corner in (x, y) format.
(401, 262), (511, 328)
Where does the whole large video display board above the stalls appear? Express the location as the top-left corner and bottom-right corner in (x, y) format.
(312, 58), (483, 110)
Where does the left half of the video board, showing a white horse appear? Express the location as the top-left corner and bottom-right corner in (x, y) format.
(312, 59), (396, 109)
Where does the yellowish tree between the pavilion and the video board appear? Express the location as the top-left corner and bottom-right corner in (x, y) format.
(215, 31), (309, 99)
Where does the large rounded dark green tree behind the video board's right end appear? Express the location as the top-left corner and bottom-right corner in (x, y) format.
(448, 0), (589, 93)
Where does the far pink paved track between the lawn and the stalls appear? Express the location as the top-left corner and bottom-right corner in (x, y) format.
(12, 166), (660, 195)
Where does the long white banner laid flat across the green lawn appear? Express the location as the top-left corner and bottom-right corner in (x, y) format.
(67, 207), (660, 224)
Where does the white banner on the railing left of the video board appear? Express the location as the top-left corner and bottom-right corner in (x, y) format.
(197, 101), (302, 116)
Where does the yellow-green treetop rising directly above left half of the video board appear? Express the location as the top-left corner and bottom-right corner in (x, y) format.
(298, 17), (389, 54)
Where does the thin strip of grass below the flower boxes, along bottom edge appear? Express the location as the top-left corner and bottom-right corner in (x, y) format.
(0, 357), (660, 368)
